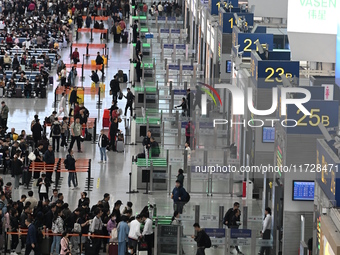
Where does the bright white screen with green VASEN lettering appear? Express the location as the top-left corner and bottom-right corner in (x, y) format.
(287, 0), (339, 34)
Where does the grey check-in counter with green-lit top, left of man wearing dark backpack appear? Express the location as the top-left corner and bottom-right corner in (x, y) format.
(137, 158), (168, 190)
